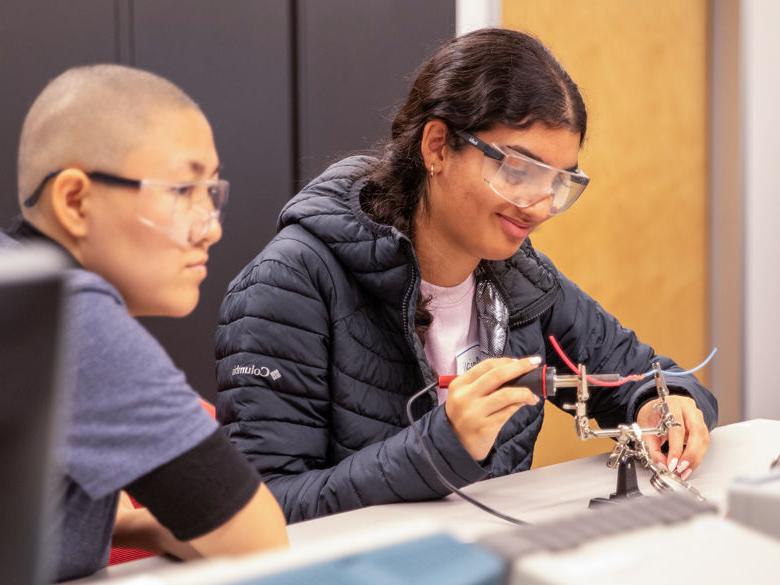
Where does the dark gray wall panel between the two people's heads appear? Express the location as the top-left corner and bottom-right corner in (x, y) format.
(132, 0), (294, 398)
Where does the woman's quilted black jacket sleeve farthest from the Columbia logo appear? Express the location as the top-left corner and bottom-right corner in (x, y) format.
(543, 260), (718, 429)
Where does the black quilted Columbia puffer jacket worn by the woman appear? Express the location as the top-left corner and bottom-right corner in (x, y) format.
(216, 157), (717, 522)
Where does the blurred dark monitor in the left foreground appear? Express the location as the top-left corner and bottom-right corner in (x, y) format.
(0, 246), (66, 585)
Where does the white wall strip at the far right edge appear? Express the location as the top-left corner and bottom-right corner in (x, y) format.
(740, 0), (780, 419)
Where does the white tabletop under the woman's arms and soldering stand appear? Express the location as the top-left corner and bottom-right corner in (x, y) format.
(86, 419), (780, 585)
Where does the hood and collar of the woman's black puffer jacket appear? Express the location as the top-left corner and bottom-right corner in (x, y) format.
(277, 156), (559, 325)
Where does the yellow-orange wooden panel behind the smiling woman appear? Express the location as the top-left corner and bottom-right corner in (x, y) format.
(503, 0), (709, 466)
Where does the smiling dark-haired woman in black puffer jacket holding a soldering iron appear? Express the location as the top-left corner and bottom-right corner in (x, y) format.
(216, 29), (717, 522)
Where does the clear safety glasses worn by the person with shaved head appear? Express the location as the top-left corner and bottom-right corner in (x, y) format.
(24, 170), (230, 246)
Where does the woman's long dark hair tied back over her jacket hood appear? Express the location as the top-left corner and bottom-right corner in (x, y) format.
(361, 29), (587, 343)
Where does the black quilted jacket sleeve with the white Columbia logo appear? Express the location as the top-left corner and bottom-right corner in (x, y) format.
(216, 230), (486, 522)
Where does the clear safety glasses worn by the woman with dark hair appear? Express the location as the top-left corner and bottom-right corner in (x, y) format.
(456, 131), (590, 215)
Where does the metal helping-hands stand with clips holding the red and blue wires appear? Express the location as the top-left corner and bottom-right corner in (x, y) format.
(563, 362), (704, 507)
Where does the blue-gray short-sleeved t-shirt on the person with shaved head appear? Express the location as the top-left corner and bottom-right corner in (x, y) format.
(52, 269), (217, 580)
